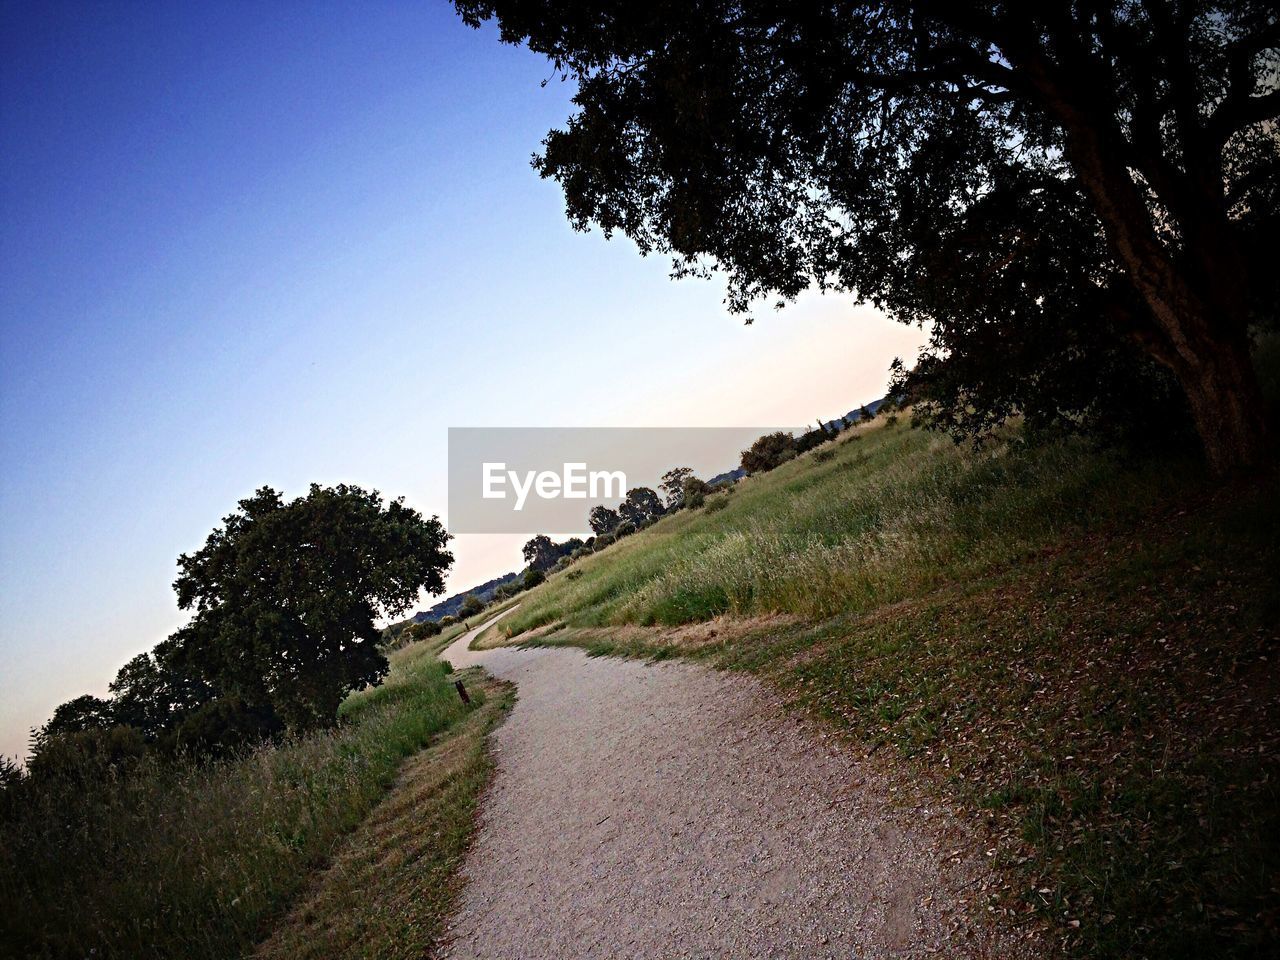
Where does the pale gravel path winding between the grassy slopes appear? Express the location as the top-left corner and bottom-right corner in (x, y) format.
(445, 616), (1023, 960)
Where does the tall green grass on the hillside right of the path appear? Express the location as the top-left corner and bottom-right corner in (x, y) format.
(507, 422), (1198, 632)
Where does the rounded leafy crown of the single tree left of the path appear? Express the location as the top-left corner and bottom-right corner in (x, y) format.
(170, 484), (453, 730)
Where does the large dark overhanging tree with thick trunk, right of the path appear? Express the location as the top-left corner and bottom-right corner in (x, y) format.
(456, 0), (1280, 471)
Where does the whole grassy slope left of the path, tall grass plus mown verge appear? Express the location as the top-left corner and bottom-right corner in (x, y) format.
(0, 634), (509, 957)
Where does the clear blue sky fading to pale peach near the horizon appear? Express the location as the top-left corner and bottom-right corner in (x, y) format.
(0, 0), (923, 755)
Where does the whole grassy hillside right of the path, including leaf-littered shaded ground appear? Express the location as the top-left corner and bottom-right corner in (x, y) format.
(491, 409), (1280, 957)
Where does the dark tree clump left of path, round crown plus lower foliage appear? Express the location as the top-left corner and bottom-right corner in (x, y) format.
(32, 484), (453, 769)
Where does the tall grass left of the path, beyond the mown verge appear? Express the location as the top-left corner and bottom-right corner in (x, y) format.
(0, 645), (483, 957)
